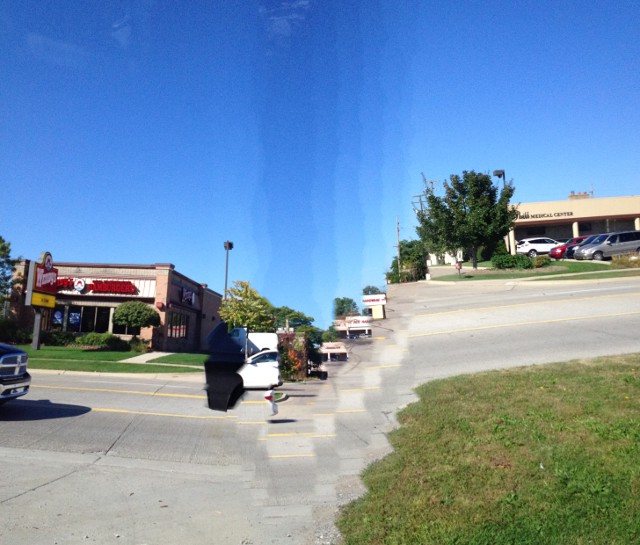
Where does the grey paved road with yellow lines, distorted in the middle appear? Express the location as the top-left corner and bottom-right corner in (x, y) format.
(0, 279), (640, 545)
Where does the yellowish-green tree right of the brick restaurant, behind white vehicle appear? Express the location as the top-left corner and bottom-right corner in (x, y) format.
(220, 280), (276, 333)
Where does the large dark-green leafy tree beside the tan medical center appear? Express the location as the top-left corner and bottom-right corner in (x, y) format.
(417, 170), (517, 268)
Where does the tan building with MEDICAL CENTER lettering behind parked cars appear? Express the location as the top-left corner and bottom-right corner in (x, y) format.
(508, 192), (640, 253)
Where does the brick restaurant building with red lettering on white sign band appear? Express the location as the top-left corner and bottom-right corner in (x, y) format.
(11, 261), (222, 352)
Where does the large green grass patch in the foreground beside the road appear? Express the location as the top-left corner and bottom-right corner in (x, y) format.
(338, 354), (640, 545)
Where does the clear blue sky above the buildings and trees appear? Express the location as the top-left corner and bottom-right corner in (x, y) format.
(0, 0), (640, 328)
